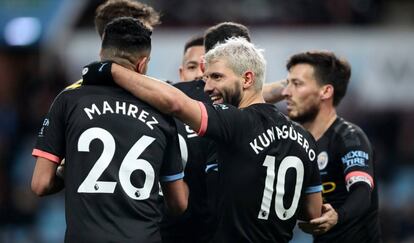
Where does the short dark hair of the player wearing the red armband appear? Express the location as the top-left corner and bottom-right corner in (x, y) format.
(286, 51), (351, 106)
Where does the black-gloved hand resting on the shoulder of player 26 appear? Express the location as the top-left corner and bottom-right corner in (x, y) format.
(82, 61), (115, 85)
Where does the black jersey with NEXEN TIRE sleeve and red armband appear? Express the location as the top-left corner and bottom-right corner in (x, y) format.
(315, 117), (380, 243)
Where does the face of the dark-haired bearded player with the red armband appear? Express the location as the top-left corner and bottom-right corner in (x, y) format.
(282, 64), (321, 123)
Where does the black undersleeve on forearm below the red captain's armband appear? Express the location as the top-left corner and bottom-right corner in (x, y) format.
(337, 183), (371, 225)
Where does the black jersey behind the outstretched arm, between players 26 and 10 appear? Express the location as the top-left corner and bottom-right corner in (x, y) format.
(161, 80), (215, 243)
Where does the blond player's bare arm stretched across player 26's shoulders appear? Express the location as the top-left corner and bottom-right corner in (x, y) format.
(112, 63), (202, 131)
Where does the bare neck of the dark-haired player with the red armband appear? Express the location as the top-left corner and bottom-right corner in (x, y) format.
(302, 106), (337, 141)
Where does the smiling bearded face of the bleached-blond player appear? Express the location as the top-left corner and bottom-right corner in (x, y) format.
(204, 59), (243, 107)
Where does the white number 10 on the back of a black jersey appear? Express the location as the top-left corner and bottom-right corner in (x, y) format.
(257, 155), (303, 220)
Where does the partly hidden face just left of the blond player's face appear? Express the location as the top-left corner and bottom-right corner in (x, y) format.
(180, 46), (204, 81)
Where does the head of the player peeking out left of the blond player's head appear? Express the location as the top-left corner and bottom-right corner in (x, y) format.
(179, 36), (204, 82)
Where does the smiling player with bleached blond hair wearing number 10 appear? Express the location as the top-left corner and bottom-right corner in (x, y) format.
(84, 38), (322, 242)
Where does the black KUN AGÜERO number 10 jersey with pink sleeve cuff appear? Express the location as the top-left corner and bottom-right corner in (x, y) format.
(198, 104), (322, 243)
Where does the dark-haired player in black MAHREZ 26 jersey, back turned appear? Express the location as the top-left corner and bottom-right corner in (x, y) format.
(32, 18), (188, 242)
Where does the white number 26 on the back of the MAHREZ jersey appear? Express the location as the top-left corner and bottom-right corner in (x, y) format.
(78, 127), (155, 200)
